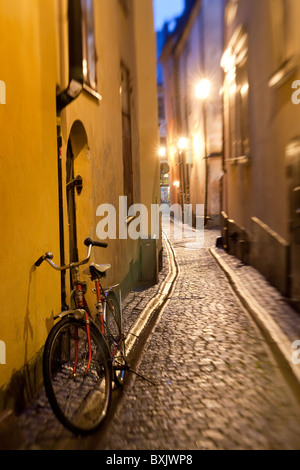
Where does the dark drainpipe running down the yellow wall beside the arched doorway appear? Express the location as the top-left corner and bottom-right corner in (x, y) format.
(56, 0), (83, 311)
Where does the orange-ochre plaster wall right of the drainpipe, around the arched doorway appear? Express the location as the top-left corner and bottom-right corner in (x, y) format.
(62, 0), (160, 294)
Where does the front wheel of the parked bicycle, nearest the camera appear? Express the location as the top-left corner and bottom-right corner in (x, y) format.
(43, 317), (112, 435)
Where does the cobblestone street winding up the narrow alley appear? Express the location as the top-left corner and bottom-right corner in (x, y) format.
(14, 218), (300, 450)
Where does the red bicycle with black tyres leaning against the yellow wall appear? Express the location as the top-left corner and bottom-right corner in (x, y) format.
(35, 238), (130, 435)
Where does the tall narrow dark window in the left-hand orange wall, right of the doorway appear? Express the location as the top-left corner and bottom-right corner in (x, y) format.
(121, 64), (133, 208)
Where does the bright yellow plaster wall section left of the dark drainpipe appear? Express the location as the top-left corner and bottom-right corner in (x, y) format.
(0, 0), (59, 387)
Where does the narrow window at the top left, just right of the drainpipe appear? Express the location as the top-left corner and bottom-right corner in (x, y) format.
(81, 0), (97, 90)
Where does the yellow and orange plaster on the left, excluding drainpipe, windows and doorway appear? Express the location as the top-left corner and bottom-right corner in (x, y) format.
(0, 0), (159, 400)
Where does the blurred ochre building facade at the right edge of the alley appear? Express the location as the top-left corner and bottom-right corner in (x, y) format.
(222, 0), (300, 301)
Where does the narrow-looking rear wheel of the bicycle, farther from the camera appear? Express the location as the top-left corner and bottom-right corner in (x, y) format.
(106, 291), (126, 387)
